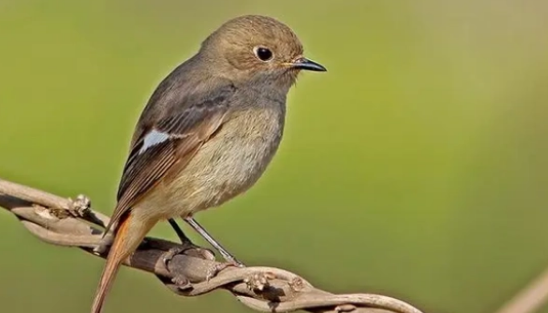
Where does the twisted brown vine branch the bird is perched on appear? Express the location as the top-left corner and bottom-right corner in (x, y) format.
(0, 179), (421, 313)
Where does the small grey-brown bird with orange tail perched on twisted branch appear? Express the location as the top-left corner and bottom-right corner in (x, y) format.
(91, 15), (326, 313)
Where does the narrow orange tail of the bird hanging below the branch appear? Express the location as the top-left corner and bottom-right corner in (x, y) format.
(91, 213), (133, 313)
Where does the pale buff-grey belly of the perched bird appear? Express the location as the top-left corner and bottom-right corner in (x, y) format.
(135, 108), (283, 219)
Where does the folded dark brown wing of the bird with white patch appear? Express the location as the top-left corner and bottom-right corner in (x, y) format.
(105, 84), (235, 233)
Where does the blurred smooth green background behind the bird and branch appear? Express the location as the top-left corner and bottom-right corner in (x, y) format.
(0, 0), (548, 313)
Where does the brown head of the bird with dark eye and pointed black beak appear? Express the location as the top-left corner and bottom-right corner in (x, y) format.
(200, 15), (326, 88)
